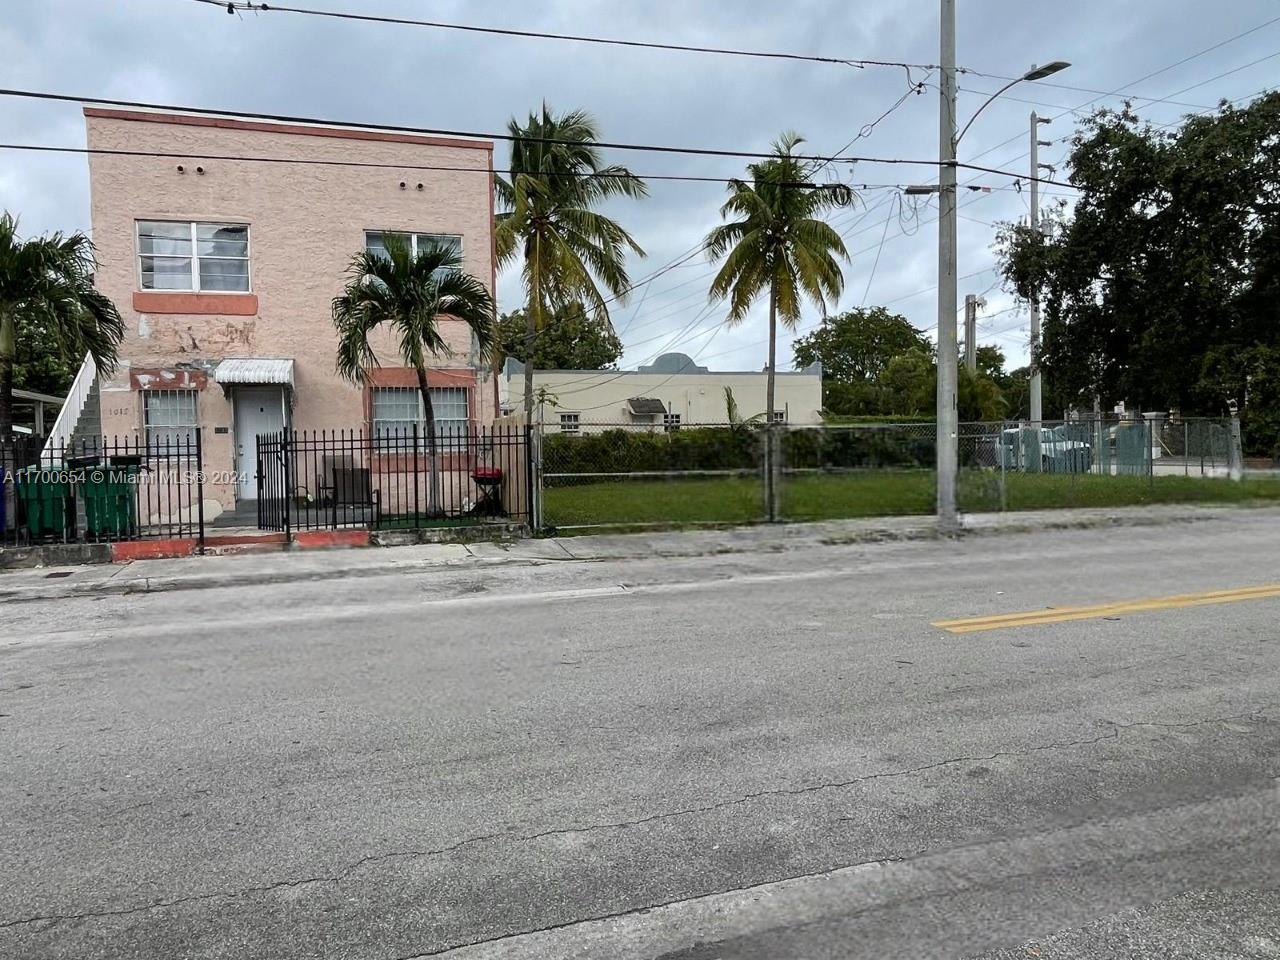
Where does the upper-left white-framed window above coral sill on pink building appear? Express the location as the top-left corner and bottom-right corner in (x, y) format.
(137, 220), (250, 293)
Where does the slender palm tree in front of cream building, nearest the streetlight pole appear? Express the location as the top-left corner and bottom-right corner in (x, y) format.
(705, 133), (854, 422)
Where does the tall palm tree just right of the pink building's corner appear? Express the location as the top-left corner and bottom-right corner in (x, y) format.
(495, 104), (649, 422)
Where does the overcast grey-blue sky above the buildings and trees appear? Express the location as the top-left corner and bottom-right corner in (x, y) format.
(0, 0), (1280, 370)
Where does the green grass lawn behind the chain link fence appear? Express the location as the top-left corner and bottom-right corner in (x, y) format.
(544, 470), (1280, 527)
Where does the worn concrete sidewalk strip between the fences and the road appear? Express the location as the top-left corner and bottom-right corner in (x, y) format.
(0, 507), (1259, 602)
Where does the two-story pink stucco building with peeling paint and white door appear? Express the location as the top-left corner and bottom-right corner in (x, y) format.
(78, 108), (497, 519)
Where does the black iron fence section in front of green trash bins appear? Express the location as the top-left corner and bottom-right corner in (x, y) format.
(0, 430), (205, 545)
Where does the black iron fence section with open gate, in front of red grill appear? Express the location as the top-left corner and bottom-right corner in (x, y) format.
(257, 425), (534, 532)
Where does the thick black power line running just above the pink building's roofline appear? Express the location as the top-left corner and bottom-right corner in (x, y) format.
(0, 88), (1071, 188)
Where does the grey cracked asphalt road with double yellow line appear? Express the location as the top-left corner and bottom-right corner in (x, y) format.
(0, 522), (1280, 960)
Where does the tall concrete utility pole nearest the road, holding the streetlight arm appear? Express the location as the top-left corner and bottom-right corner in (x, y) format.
(936, 0), (959, 534)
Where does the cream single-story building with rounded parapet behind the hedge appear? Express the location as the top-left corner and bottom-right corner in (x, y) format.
(499, 353), (822, 433)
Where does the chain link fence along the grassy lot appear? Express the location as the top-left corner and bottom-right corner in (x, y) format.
(540, 417), (1240, 530)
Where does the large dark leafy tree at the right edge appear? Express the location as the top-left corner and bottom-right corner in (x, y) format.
(998, 93), (1280, 440)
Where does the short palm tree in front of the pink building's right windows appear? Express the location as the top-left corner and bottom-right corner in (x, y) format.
(333, 234), (497, 512)
